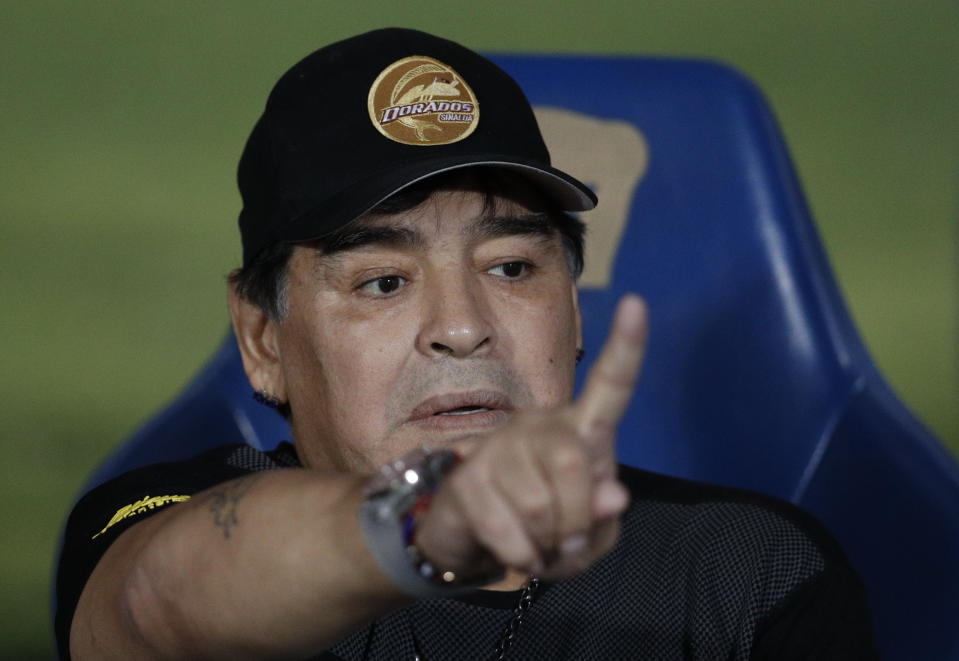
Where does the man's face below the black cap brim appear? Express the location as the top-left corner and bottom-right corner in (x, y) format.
(271, 179), (581, 471)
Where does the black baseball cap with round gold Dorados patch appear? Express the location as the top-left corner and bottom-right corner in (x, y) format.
(237, 28), (596, 265)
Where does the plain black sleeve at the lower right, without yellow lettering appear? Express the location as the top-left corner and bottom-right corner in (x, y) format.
(749, 563), (879, 661)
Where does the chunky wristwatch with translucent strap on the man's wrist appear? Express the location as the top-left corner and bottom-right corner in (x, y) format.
(359, 446), (495, 598)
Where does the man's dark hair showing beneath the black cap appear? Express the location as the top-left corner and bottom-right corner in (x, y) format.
(229, 167), (585, 320)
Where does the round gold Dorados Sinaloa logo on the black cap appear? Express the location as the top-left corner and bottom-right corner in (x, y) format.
(368, 55), (479, 145)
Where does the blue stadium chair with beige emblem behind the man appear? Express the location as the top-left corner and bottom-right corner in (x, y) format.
(63, 55), (959, 661)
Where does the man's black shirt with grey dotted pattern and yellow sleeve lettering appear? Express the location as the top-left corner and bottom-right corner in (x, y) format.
(56, 444), (878, 661)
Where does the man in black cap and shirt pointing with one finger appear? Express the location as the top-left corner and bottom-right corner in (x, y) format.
(57, 29), (875, 660)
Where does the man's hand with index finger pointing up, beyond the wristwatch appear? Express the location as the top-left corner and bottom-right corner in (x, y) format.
(416, 295), (647, 578)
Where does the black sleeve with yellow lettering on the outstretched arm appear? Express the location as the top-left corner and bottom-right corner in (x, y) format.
(54, 446), (252, 659)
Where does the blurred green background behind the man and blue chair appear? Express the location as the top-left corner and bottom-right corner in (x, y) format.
(0, 0), (959, 659)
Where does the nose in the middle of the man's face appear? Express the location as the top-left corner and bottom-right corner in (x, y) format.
(417, 270), (496, 358)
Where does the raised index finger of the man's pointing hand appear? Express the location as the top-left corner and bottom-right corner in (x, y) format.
(575, 294), (648, 438)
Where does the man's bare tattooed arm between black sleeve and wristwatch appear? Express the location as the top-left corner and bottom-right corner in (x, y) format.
(71, 470), (405, 659)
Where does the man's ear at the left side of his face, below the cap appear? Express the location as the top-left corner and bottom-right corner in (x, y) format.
(228, 274), (287, 403)
